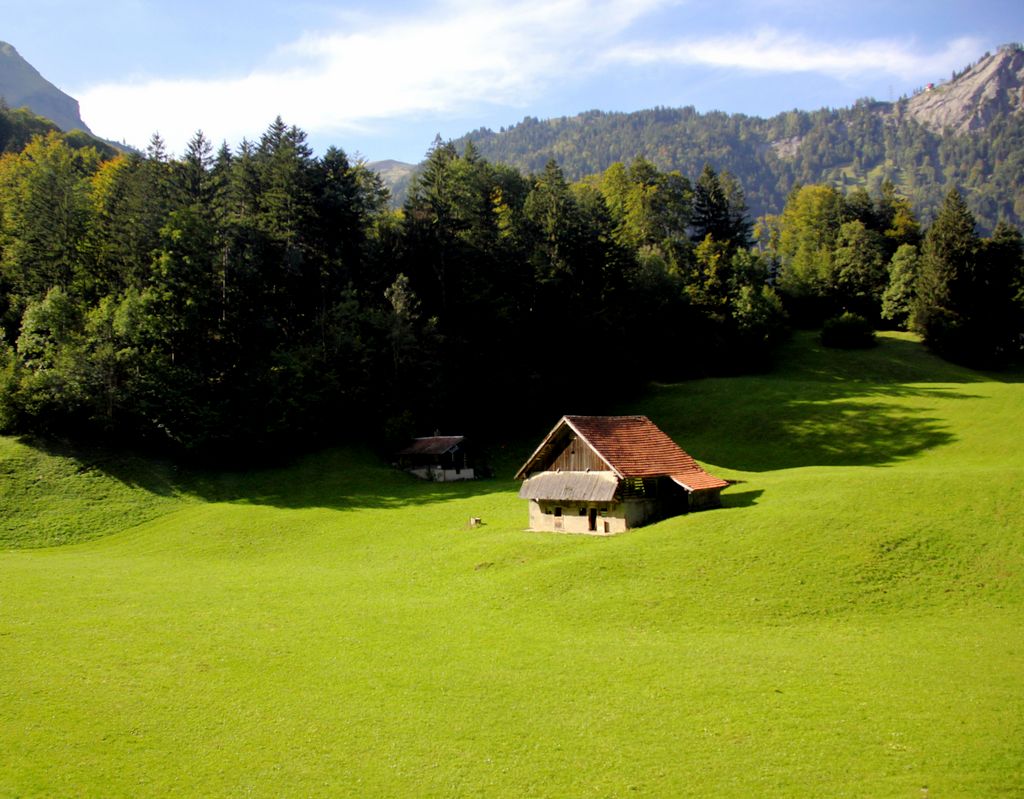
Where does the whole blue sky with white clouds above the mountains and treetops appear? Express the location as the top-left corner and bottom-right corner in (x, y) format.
(0, 0), (1024, 163)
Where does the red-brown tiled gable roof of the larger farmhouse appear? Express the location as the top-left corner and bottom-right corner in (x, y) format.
(516, 416), (729, 491)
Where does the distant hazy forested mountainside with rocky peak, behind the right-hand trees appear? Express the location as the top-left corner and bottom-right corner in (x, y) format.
(456, 45), (1024, 230)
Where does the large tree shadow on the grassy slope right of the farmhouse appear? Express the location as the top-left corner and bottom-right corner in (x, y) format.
(643, 334), (995, 475)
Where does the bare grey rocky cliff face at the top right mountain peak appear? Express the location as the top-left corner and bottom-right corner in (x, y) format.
(901, 45), (1024, 133)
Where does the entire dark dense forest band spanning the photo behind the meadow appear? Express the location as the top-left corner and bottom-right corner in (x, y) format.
(0, 119), (1024, 457)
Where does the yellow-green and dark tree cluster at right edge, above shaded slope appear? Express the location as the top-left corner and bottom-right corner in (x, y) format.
(758, 181), (1024, 368)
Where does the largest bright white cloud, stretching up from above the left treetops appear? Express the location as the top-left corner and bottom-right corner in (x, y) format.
(79, 0), (670, 150)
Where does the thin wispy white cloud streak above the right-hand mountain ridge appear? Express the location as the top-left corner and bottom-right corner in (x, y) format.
(606, 29), (982, 80)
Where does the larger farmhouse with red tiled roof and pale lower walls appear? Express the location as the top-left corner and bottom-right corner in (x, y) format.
(516, 416), (729, 535)
